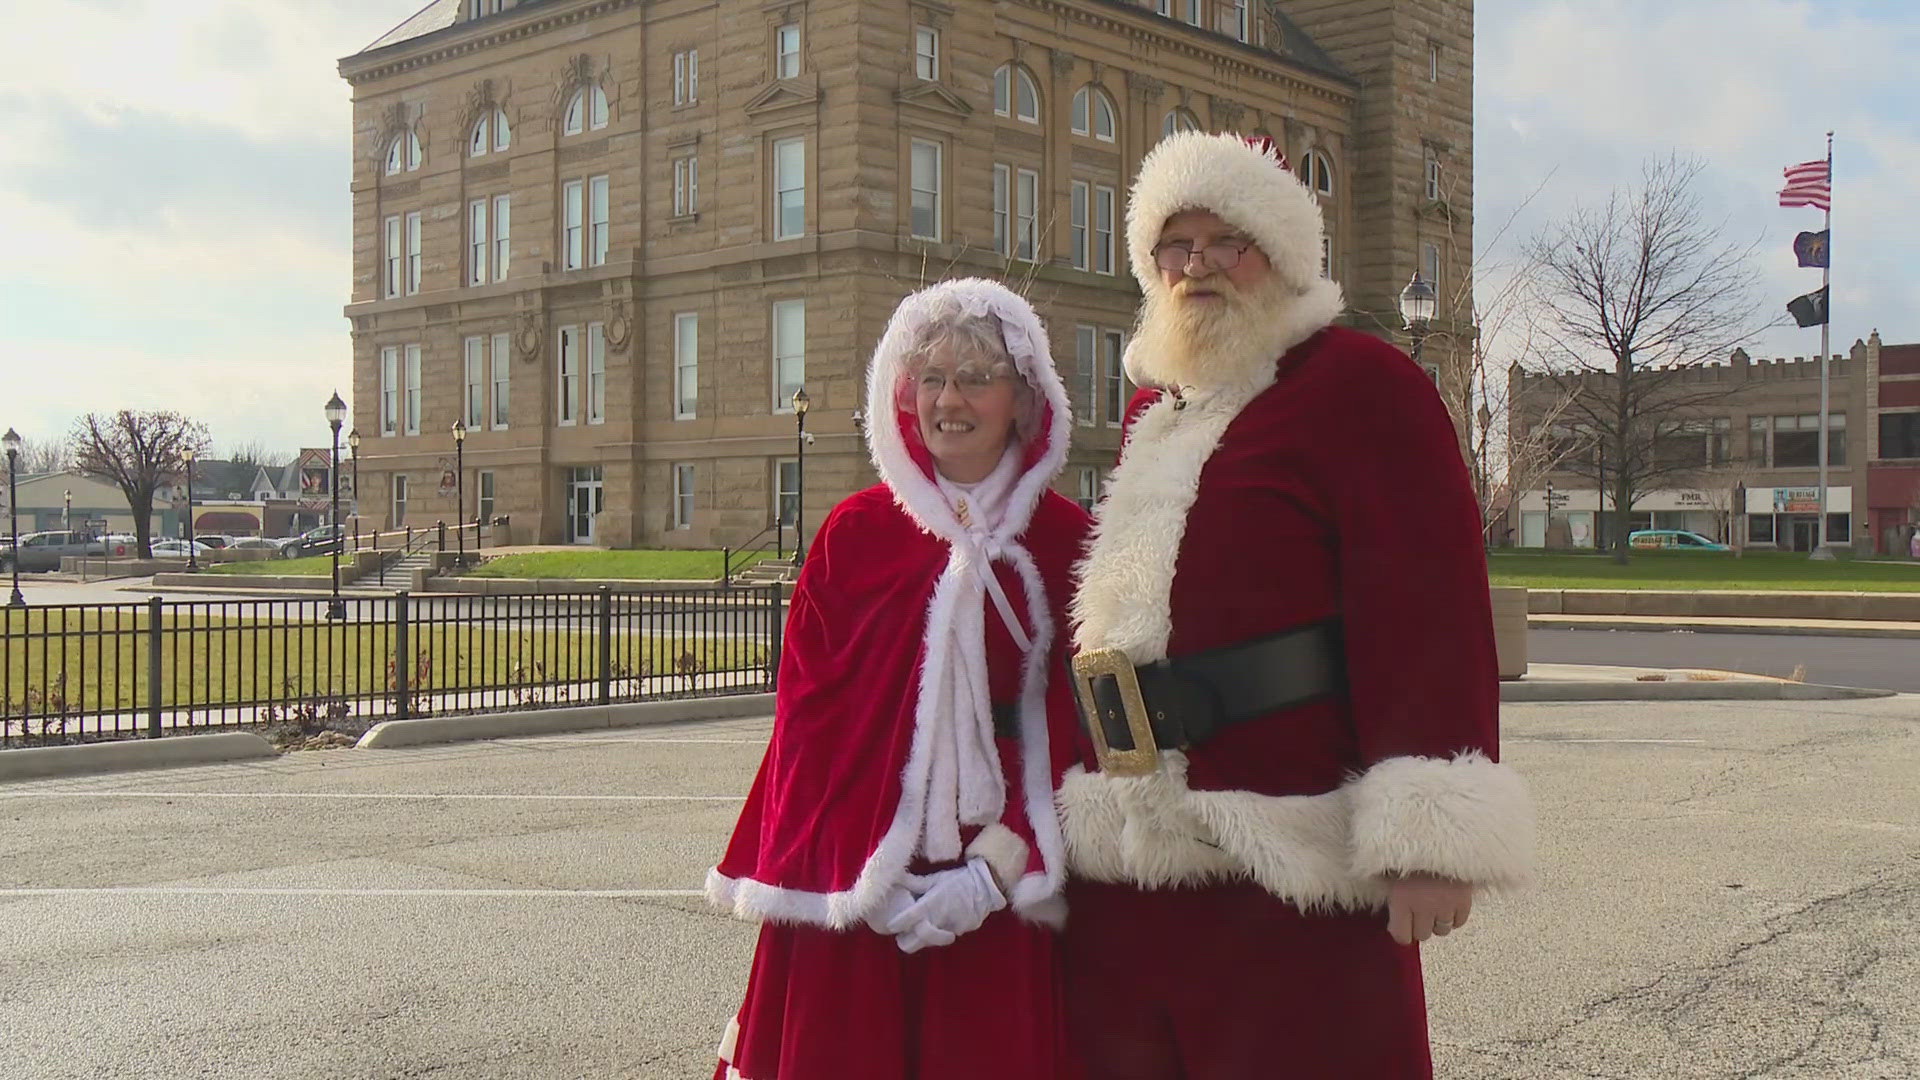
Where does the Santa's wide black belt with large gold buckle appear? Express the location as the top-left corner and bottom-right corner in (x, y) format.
(1073, 621), (1346, 776)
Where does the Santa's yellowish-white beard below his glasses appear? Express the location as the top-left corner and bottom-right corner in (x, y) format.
(1129, 273), (1296, 388)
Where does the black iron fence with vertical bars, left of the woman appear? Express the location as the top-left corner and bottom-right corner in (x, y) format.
(0, 584), (781, 746)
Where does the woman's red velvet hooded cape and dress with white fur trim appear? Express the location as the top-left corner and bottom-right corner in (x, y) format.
(707, 279), (1089, 1080)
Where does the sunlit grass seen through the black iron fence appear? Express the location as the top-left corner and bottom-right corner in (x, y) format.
(0, 609), (766, 717)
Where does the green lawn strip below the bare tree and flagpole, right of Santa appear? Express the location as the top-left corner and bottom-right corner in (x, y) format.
(1488, 552), (1920, 592)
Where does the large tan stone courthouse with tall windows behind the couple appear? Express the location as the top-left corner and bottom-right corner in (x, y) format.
(340, 0), (1473, 548)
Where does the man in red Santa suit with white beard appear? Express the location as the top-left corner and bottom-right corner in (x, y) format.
(1056, 133), (1532, 1080)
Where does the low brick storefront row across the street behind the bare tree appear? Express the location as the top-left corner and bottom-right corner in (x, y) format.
(1509, 331), (1920, 553)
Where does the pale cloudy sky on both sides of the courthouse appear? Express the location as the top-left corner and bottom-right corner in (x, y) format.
(0, 0), (1920, 450)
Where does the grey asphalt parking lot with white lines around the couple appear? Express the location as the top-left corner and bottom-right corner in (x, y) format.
(0, 696), (1920, 1080)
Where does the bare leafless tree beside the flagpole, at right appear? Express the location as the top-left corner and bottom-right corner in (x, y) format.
(1526, 156), (1766, 563)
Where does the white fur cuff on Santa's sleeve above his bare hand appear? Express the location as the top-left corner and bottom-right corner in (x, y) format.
(1346, 751), (1534, 890)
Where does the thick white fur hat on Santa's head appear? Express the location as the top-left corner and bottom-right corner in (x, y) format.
(1127, 131), (1325, 294)
